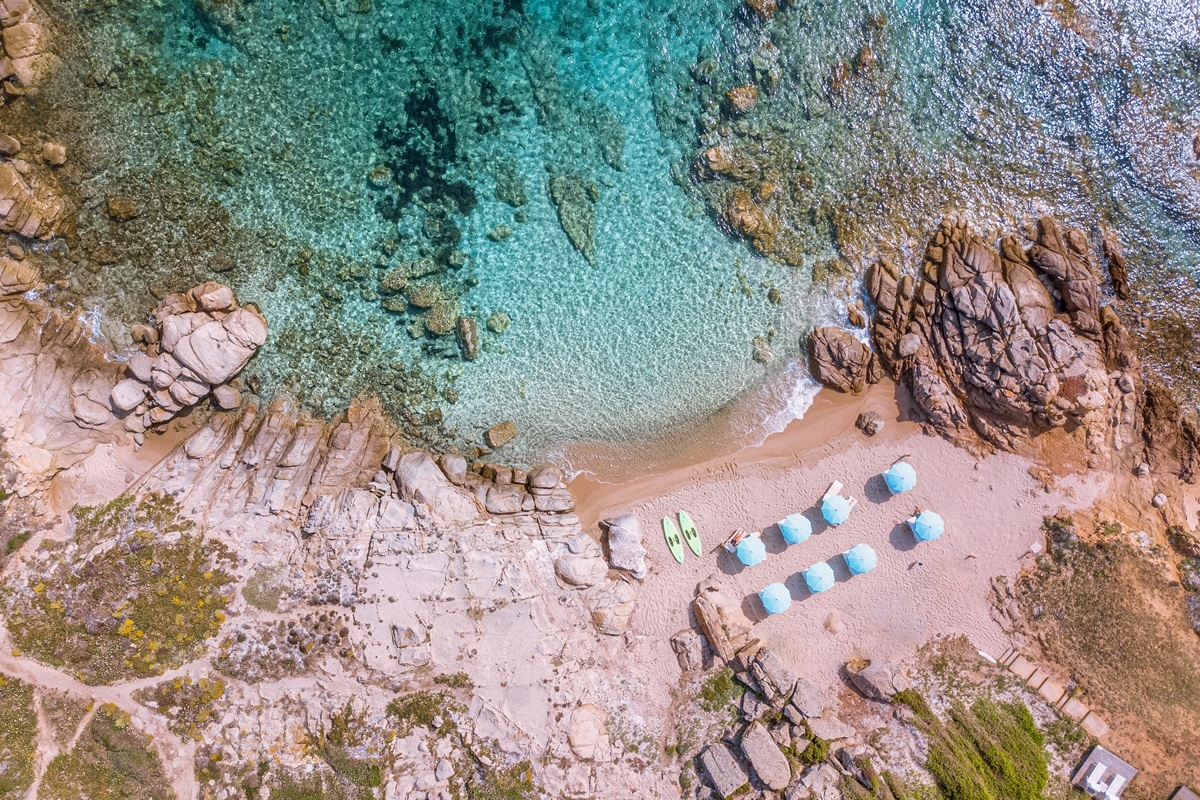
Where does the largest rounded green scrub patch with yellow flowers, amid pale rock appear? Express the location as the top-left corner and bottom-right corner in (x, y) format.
(6, 494), (232, 684)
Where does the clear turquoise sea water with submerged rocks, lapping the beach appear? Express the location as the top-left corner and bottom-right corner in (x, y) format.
(31, 0), (1200, 469)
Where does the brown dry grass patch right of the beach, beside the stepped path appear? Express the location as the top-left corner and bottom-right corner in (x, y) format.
(1018, 518), (1200, 798)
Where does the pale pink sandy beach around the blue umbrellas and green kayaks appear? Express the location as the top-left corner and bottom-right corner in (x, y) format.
(571, 384), (1108, 686)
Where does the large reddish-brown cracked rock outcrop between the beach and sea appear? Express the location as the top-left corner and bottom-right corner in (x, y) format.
(865, 217), (1140, 452)
